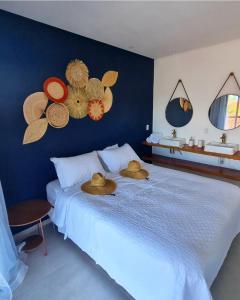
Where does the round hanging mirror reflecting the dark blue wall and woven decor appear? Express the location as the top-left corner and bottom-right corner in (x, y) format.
(165, 98), (193, 127)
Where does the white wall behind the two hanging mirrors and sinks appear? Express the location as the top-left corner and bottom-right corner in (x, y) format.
(153, 39), (240, 169)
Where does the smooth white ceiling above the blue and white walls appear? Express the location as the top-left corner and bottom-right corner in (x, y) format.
(0, 1), (240, 58)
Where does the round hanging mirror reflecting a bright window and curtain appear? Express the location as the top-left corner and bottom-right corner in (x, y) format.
(208, 95), (240, 130)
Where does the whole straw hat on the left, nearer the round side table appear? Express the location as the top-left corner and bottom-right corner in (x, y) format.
(81, 173), (117, 195)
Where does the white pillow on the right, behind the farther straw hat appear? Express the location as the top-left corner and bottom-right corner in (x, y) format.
(98, 144), (141, 172)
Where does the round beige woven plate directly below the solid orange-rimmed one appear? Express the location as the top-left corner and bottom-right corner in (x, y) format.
(46, 103), (69, 128)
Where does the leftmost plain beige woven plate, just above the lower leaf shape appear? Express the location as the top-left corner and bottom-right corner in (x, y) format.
(23, 92), (48, 124)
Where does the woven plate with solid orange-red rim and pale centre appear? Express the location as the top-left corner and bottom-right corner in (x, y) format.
(43, 77), (68, 103)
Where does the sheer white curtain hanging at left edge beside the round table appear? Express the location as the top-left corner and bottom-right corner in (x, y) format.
(0, 182), (27, 300)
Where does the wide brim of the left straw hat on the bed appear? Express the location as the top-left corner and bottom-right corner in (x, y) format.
(81, 179), (117, 195)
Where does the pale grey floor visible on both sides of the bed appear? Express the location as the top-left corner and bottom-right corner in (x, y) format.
(13, 225), (240, 300)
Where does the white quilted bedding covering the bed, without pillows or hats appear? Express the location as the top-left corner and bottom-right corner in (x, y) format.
(47, 164), (240, 300)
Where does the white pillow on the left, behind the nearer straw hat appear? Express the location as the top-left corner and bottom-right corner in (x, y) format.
(50, 151), (105, 189)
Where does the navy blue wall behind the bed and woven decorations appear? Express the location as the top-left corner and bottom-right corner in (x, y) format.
(0, 10), (154, 206)
